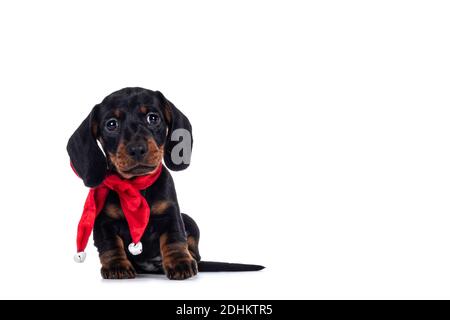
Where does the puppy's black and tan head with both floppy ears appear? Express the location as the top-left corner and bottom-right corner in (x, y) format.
(67, 88), (193, 187)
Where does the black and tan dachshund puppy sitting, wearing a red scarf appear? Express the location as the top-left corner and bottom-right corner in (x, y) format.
(67, 88), (263, 279)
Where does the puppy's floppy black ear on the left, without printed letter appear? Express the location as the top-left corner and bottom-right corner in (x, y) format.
(67, 105), (107, 188)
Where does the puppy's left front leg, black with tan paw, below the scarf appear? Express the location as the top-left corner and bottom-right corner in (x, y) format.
(94, 214), (136, 279)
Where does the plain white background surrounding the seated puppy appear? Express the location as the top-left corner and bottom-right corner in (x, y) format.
(0, 0), (450, 299)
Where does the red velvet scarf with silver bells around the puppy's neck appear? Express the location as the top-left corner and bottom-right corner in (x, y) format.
(75, 165), (162, 262)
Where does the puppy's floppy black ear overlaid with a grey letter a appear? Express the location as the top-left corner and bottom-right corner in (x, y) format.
(157, 91), (194, 171)
